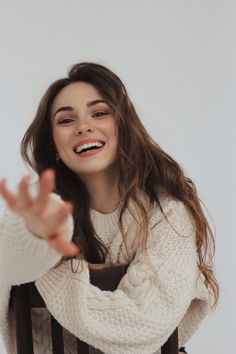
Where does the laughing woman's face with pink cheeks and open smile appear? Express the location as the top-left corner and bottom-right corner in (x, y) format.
(51, 82), (117, 177)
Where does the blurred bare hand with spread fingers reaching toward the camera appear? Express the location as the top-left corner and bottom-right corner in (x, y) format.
(0, 170), (79, 256)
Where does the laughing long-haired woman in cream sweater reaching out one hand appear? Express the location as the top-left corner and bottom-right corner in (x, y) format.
(0, 63), (218, 354)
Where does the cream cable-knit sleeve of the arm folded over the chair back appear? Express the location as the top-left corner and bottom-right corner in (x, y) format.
(36, 201), (201, 354)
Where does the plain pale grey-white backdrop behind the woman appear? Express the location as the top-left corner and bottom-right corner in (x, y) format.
(0, 0), (236, 354)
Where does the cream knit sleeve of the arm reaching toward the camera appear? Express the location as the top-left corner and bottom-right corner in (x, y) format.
(0, 194), (73, 285)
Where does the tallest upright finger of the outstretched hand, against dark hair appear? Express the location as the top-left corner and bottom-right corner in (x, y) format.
(34, 170), (55, 213)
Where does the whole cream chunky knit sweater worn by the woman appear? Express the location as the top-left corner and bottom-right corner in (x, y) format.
(0, 191), (210, 354)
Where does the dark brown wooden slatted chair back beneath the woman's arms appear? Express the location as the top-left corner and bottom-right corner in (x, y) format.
(10, 265), (178, 354)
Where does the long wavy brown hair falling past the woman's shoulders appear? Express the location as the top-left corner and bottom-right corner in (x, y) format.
(21, 62), (219, 307)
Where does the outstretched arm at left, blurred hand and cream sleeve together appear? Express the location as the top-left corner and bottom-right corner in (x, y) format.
(0, 170), (78, 285)
